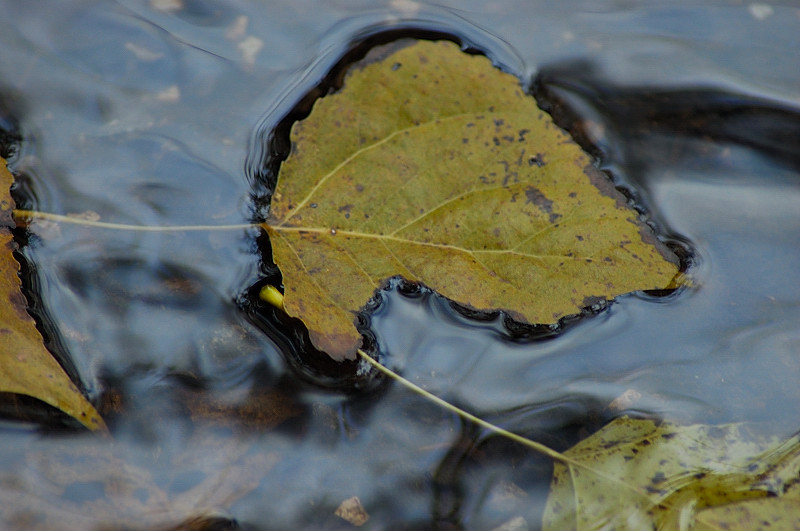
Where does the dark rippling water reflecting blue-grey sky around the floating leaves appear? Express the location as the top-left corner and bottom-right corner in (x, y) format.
(0, 0), (800, 529)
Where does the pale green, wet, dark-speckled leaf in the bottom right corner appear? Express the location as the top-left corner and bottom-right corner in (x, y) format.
(544, 417), (800, 531)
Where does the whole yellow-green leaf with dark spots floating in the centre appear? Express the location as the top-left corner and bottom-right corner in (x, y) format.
(266, 41), (677, 359)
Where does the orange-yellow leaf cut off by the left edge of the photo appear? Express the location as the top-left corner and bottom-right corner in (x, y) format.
(0, 158), (105, 430)
